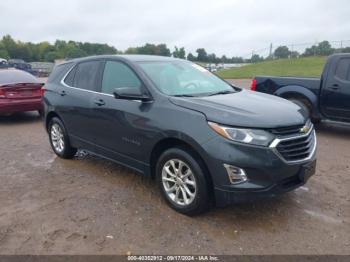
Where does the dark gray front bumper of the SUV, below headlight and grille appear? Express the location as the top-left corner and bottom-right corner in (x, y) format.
(202, 136), (316, 206)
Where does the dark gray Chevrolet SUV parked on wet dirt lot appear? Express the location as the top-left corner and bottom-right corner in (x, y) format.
(44, 55), (316, 215)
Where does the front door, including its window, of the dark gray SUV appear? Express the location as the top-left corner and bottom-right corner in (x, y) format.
(93, 61), (154, 171)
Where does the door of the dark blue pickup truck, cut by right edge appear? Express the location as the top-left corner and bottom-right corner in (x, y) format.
(321, 55), (350, 120)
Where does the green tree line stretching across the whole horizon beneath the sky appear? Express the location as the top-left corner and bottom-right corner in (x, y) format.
(0, 35), (350, 64)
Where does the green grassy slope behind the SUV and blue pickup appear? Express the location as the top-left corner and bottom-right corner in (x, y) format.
(217, 57), (326, 79)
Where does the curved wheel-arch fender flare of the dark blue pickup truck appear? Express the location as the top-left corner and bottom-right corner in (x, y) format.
(274, 85), (320, 117)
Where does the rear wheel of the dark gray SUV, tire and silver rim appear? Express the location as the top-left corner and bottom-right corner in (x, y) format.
(48, 117), (77, 159)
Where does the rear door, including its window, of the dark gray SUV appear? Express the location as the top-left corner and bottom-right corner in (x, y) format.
(59, 60), (102, 150)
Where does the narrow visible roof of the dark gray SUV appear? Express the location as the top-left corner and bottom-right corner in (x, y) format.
(59, 55), (182, 64)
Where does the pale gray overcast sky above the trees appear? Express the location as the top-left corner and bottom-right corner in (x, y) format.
(0, 0), (350, 56)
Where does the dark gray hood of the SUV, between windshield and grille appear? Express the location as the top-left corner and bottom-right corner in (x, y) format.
(170, 90), (307, 128)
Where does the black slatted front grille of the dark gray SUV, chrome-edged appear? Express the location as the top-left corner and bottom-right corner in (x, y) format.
(276, 129), (316, 162)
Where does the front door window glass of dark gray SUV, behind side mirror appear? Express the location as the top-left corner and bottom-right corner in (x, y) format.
(101, 61), (141, 94)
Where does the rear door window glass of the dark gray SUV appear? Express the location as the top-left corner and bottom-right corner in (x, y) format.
(74, 61), (100, 91)
